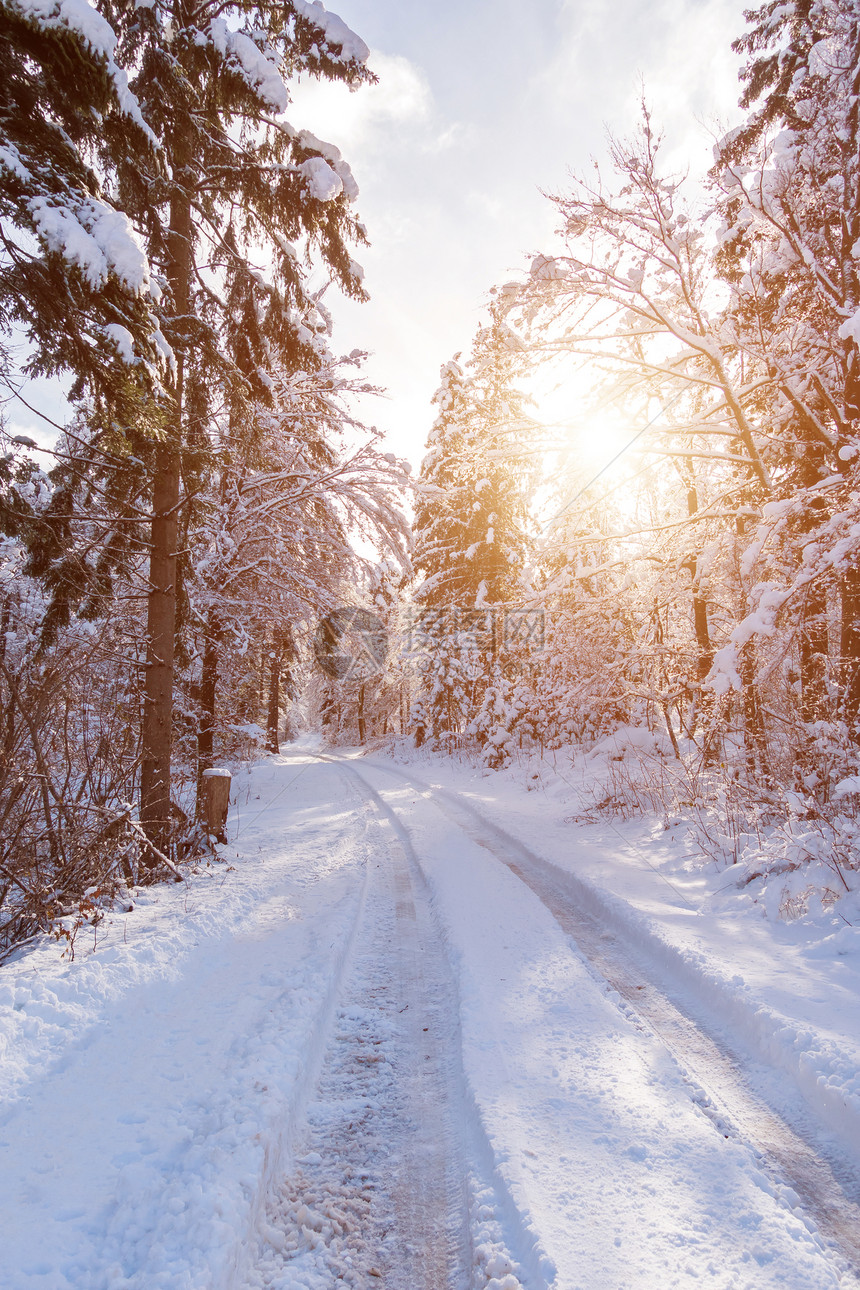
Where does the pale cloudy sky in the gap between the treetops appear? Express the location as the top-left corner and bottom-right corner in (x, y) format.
(291, 0), (744, 466)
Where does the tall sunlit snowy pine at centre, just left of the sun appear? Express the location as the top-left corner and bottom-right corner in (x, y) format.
(413, 306), (531, 735)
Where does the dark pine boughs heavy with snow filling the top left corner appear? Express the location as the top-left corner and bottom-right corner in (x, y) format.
(0, 0), (165, 421)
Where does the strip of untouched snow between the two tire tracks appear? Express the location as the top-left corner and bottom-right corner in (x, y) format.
(340, 761), (856, 1290)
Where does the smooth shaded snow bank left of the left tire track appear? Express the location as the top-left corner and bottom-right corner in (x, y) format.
(0, 761), (365, 1290)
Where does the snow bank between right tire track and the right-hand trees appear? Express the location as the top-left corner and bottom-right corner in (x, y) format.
(362, 751), (860, 1161)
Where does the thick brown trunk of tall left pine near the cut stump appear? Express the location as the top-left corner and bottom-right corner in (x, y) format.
(141, 133), (193, 871)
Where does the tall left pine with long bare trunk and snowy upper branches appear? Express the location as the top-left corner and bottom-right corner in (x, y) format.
(88, 0), (371, 851)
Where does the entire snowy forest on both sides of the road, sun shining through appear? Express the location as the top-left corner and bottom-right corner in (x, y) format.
(0, 0), (860, 952)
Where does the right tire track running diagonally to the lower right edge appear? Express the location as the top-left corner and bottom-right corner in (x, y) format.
(342, 762), (860, 1286)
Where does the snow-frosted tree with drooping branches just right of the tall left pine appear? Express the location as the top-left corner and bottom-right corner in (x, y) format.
(191, 345), (407, 770)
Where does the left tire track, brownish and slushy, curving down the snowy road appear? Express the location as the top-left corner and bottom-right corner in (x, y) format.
(244, 759), (510, 1290)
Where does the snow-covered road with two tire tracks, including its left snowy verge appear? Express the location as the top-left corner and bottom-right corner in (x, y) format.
(0, 749), (860, 1290)
